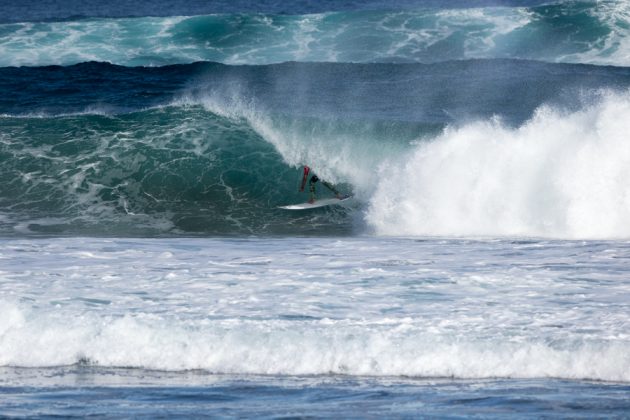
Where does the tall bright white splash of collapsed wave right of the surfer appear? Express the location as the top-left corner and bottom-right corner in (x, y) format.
(366, 93), (630, 238)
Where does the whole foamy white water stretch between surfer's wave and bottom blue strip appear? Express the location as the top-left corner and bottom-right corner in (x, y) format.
(0, 238), (630, 382)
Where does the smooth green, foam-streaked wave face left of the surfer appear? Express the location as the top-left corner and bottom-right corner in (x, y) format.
(2, 108), (302, 235)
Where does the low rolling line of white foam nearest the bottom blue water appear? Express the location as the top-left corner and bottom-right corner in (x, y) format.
(0, 302), (630, 381)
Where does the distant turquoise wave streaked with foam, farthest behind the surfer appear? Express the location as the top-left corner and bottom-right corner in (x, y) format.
(0, 1), (630, 66)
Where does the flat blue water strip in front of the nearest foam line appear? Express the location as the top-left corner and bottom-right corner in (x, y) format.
(0, 367), (630, 419)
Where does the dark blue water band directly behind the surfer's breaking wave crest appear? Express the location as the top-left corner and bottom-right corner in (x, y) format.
(0, 60), (630, 121)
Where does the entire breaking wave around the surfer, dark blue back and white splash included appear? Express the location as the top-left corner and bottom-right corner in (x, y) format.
(0, 60), (630, 237)
